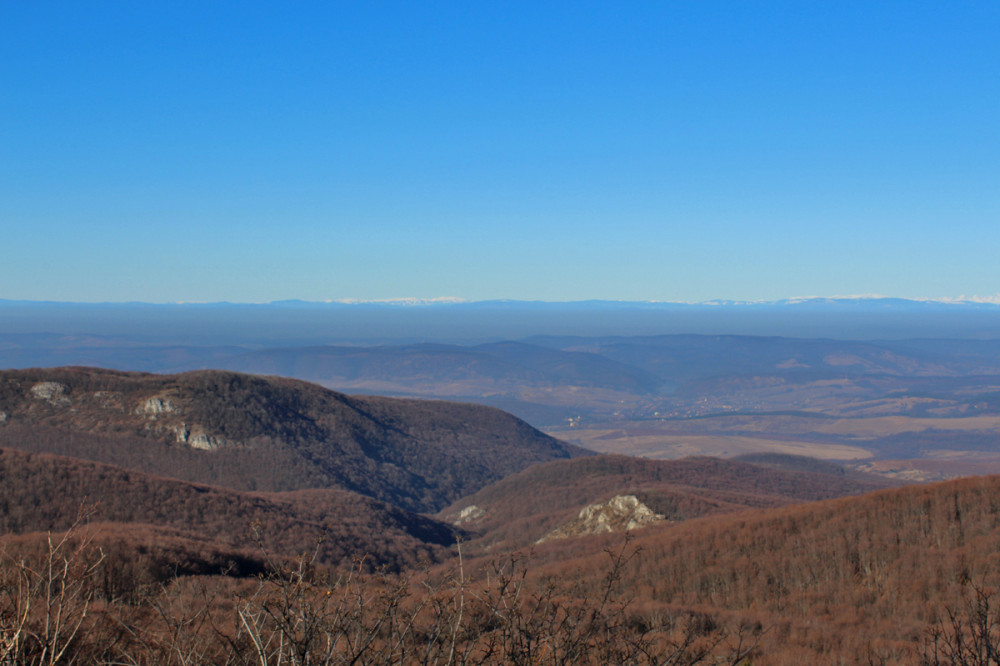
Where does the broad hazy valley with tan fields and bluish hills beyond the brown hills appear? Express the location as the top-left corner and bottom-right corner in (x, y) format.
(7, 335), (1000, 480)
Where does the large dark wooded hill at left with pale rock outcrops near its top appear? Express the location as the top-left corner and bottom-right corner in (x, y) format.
(0, 368), (583, 511)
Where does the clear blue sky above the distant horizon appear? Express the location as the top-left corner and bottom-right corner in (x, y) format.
(0, 0), (1000, 302)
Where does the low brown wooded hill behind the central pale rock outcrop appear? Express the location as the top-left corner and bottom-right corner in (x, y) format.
(438, 455), (888, 552)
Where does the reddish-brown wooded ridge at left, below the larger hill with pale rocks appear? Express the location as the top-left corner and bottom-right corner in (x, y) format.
(0, 449), (455, 571)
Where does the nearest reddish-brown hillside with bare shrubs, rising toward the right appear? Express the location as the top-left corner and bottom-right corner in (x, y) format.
(0, 466), (1000, 666)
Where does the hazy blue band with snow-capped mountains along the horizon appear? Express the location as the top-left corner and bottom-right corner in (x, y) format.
(0, 297), (1000, 347)
